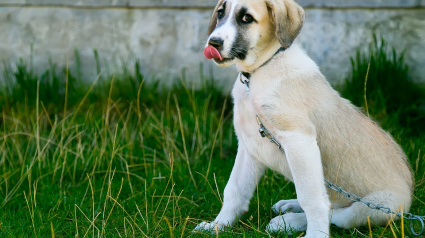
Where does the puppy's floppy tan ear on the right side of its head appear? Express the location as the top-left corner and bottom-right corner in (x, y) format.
(266, 0), (305, 48)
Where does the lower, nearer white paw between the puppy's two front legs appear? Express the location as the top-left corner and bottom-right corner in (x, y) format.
(266, 213), (307, 234)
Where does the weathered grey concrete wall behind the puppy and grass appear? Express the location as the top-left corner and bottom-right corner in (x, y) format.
(0, 0), (425, 83)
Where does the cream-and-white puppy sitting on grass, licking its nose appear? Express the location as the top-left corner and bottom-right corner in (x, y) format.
(194, 0), (414, 237)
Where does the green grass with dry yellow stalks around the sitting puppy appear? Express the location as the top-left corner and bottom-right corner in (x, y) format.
(0, 39), (425, 237)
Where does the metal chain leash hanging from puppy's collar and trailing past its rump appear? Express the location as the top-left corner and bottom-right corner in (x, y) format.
(239, 73), (425, 236)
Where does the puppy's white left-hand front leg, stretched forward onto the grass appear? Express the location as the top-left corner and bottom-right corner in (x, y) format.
(195, 141), (265, 232)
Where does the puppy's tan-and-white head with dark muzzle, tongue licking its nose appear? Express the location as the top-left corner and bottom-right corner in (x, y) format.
(204, 0), (304, 66)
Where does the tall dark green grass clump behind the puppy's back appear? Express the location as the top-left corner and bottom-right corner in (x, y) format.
(340, 36), (425, 136)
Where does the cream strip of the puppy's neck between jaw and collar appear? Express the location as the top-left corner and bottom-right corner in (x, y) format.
(236, 41), (286, 78)
